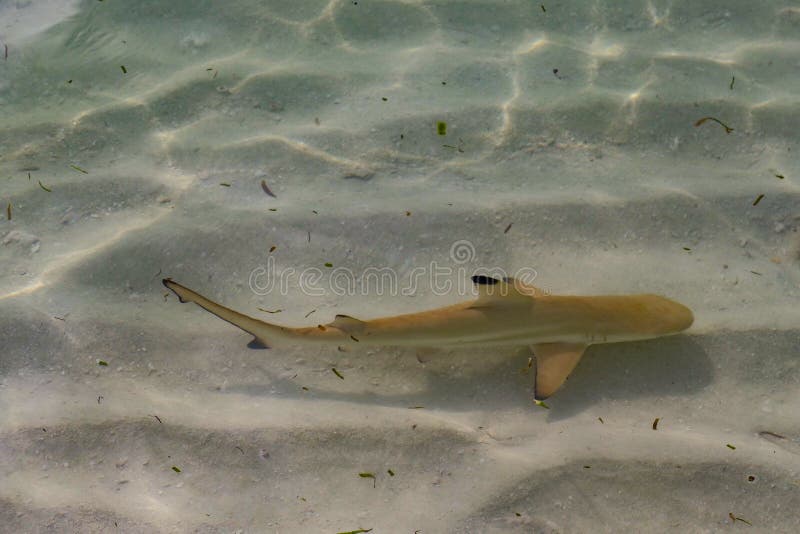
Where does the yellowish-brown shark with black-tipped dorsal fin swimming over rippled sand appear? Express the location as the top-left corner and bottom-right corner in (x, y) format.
(162, 275), (694, 401)
